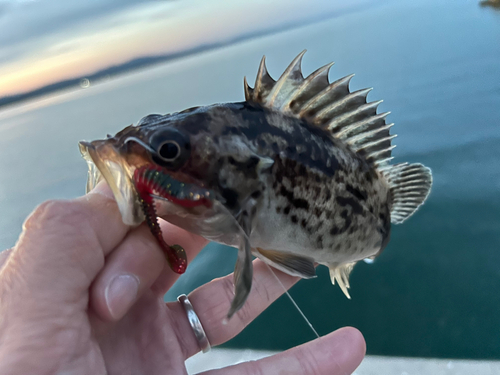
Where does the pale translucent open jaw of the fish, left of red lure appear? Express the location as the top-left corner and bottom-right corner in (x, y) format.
(80, 140), (145, 226)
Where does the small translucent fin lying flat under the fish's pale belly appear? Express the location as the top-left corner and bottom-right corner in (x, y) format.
(256, 248), (316, 279)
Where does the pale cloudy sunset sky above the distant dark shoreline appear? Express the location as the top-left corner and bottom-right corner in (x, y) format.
(0, 0), (360, 98)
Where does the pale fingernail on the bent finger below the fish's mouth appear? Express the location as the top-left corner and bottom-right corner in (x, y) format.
(104, 274), (140, 320)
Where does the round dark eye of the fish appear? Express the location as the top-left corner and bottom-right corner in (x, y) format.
(149, 127), (191, 169)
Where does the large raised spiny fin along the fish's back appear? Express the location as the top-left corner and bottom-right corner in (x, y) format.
(244, 50), (396, 167)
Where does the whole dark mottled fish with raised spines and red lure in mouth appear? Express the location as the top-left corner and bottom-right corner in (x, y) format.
(80, 50), (432, 319)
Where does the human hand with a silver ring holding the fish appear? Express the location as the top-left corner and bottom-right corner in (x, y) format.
(0, 184), (365, 375)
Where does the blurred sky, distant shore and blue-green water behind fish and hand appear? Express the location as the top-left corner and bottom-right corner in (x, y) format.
(0, 0), (500, 359)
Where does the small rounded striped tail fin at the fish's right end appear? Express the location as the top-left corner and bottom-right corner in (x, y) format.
(381, 163), (432, 224)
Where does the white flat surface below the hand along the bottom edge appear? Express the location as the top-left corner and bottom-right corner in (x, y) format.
(186, 349), (500, 375)
